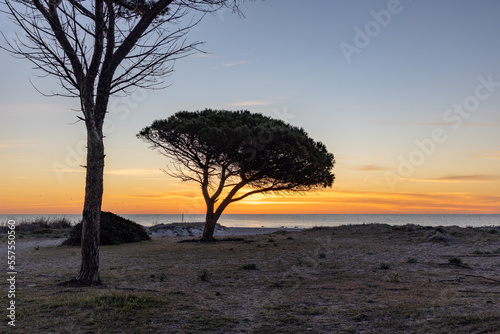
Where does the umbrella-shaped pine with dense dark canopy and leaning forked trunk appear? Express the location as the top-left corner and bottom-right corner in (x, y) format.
(137, 109), (335, 241)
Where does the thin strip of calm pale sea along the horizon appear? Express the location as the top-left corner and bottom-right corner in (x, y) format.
(0, 214), (500, 228)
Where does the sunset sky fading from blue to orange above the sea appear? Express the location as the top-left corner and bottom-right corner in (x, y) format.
(0, 0), (500, 214)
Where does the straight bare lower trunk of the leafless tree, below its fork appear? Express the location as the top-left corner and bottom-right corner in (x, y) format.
(76, 126), (104, 285)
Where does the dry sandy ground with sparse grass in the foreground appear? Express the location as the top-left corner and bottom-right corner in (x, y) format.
(0, 225), (500, 334)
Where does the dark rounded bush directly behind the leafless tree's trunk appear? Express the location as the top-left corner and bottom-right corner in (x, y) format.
(63, 211), (151, 246)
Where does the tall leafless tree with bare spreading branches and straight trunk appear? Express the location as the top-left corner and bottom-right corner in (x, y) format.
(3, 0), (239, 285)
